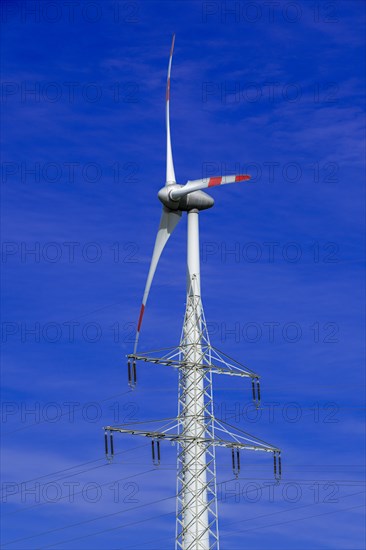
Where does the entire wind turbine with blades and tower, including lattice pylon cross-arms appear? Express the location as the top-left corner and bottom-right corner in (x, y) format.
(105, 36), (281, 550)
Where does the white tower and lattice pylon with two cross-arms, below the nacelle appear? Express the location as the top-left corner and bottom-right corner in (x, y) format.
(104, 211), (281, 550)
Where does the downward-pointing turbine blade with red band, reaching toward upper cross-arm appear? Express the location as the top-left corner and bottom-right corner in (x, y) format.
(133, 207), (182, 353)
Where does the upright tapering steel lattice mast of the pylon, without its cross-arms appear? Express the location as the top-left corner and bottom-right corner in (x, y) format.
(175, 284), (219, 550)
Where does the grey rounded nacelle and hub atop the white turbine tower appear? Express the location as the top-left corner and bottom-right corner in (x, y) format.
(158, 184), (215, 212)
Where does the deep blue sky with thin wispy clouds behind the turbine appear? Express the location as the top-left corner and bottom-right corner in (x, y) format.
(1, 0), (365, 550)
